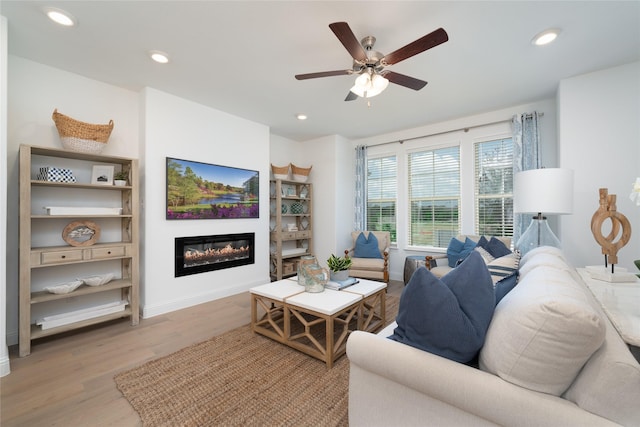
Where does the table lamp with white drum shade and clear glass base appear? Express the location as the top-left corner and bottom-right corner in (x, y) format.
(513, 168), (573, 255)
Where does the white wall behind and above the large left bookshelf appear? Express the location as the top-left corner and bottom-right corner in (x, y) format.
(6, 55), (139, 344)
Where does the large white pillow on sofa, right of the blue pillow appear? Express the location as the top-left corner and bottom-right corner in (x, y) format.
(480, 268), (606, 396)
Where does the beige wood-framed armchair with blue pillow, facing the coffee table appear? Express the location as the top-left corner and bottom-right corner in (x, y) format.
(344, 231), (391, 283)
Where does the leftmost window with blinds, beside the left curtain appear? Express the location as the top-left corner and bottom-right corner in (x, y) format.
(367, 156), (398, 243)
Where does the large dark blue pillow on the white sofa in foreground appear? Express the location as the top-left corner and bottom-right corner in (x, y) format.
(389, 252), (495, 363)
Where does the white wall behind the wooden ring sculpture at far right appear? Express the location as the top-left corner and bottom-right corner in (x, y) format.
(558, 62), (640, 272)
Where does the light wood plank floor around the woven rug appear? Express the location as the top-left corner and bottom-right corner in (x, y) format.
(0, 281), (403, 427)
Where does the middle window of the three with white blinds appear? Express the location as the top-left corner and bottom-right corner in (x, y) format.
(408, 146), (460, 247)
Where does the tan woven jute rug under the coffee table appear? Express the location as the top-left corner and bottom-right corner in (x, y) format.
(114, 295), (399, 426)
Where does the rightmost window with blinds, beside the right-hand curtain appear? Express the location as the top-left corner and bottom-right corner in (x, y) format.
(474, 138), (513, 236)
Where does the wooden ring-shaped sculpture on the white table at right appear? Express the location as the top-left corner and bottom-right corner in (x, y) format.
(591, 188), (631, 274)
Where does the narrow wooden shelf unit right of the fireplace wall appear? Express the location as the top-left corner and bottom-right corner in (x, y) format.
(269, 179), (313, 281)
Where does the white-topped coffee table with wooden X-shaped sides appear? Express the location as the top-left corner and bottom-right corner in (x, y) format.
(249, 279), (387, 368)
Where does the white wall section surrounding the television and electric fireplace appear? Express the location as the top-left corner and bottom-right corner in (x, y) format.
(141, 88), (270, 317)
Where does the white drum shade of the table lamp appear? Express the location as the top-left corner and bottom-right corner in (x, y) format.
(513, 168), (573, 215)
